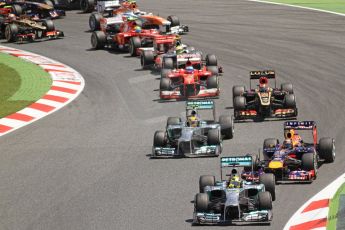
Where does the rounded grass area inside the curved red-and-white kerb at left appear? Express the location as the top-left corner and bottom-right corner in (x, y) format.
(0, 53), (52, 118)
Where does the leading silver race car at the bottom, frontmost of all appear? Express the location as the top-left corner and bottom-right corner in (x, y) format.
(193, 156), (275, 224)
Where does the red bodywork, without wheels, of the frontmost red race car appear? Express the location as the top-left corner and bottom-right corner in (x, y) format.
(160, 66), (219, 99)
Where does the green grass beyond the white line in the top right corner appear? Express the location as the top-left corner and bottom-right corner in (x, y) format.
(268, 0), (345, 13)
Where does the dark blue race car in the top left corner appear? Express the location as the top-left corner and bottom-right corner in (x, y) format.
(0, 0), (66, 19)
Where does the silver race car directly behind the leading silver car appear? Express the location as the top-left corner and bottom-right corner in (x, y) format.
(152, 100), (234, 157)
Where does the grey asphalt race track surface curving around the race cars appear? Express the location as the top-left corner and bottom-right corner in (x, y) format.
(0, 0), (345, 230)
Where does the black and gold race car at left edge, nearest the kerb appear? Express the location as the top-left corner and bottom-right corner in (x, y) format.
(0, 16), (64, 42)
